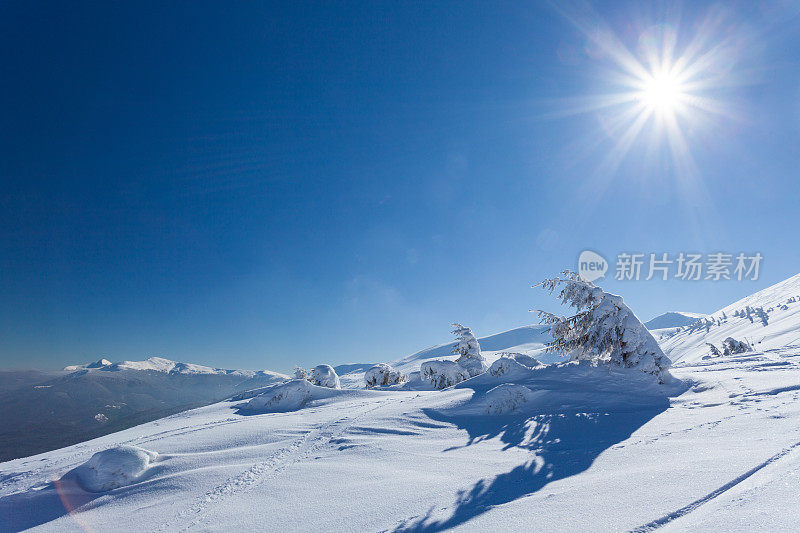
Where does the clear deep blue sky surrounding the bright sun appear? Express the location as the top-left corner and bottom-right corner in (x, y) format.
(0, 2), (800, 370)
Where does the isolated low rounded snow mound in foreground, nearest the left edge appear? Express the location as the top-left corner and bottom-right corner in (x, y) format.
(73, 446), (158, 492)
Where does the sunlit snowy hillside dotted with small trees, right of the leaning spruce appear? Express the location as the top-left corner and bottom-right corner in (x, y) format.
(656, 274), (800, 363)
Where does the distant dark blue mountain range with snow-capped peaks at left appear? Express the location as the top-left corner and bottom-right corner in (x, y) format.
(0, 357), (287, 461)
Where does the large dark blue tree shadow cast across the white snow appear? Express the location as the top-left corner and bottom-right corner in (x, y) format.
(396, 391), (669, 532)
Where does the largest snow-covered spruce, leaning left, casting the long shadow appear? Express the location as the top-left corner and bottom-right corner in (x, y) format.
(539, 270), (671, 383)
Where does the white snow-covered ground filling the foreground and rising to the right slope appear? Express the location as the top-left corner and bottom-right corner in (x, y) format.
(0, 276), (800, 531)
